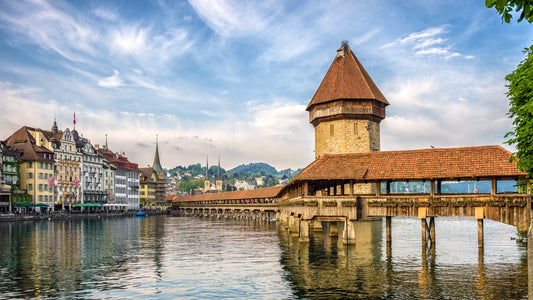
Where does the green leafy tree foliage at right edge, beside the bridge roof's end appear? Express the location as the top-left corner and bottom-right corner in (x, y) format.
(505, 45), (533, 178)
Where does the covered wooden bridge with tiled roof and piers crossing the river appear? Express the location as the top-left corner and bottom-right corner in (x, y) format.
(169, 146), (531, 245)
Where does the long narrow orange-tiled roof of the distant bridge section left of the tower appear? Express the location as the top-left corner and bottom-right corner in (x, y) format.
(167, 185), (284, 202)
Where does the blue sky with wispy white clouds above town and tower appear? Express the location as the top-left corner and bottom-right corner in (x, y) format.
(0, 0), (533, 170)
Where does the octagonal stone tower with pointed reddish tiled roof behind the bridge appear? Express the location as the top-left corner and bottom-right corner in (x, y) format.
(306, 42), (389, 158)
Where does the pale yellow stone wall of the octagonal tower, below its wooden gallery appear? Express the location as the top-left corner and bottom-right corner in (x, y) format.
(315, 119), (380, 158)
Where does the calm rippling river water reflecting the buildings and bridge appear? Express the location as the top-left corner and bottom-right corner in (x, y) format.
(0, 216), (527, 299)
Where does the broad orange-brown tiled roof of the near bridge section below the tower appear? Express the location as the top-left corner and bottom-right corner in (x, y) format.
(289, 146), (526, 184)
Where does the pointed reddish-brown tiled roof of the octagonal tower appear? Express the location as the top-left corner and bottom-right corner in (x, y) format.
(306, 42), (389, 111)
